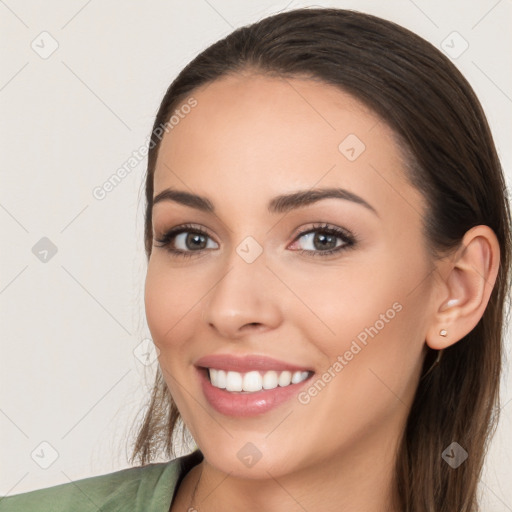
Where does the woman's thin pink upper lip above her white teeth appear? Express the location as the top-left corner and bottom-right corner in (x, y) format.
(195, 354), (312, 373)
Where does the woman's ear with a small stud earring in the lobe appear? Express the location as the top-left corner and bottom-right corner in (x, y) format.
(426, 225), (500, 350)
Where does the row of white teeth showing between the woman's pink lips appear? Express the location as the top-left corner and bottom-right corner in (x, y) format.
(209, 368), (309, 393)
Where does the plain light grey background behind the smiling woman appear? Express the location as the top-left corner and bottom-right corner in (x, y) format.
(0, 0), (512, 512)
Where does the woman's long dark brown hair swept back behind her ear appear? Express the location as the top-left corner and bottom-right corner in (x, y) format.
(127, 8), (511, 512)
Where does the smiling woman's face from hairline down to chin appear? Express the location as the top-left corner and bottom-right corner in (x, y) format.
(145, 75), (440, 478)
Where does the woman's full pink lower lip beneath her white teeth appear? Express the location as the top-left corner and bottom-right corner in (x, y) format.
(198, 368), (312, 417)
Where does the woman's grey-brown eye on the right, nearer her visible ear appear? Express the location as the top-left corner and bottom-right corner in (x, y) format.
(288, 224), (356, 256)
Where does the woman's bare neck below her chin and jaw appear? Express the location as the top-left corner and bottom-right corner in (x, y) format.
(178, 424), (398, 512)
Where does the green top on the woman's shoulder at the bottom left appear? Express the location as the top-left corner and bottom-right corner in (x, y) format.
(0, 449), (203, 512)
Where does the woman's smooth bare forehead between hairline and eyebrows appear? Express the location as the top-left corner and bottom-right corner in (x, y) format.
(154, 70), (421, 218)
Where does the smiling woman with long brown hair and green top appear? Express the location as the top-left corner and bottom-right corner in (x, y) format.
(0, 5), (510, 512)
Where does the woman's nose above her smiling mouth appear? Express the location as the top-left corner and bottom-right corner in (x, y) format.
(202, 252), (283, 340)
